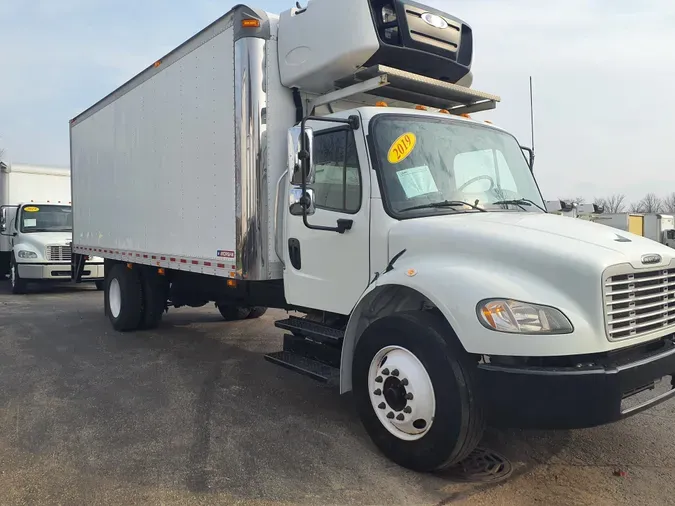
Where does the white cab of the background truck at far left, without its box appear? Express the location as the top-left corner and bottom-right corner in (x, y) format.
(0, 202), (104, 294)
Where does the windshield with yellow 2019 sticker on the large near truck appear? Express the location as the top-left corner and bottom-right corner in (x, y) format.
(372, 115), (544, 218)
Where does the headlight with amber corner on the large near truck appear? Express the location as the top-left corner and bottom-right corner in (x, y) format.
(477, 299), (574, 334)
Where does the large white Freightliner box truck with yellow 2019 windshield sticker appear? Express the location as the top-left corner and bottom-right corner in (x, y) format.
(70, 0), (675, 471)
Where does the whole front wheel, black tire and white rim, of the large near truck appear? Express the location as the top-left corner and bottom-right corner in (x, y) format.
(352, 311), (484, 471)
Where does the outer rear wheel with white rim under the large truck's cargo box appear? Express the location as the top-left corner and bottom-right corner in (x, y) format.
(105, 264), (143, 332)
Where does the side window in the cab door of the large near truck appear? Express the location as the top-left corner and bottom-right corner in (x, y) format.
(310, 129), (361, 214)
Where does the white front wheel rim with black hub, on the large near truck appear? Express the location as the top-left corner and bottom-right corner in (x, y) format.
(368, 346), (436, 441)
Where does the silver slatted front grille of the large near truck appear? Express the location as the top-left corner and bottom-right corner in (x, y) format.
(604, 268), (675, 340)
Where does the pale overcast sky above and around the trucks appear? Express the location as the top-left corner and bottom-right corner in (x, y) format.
(0, 0), (675, 205)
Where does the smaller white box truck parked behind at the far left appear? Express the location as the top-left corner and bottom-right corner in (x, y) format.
(0, 163), (104, 294)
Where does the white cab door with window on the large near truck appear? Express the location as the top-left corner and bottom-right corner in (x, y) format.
(284, 122), (370, 315)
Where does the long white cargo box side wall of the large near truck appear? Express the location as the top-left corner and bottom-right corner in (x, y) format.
(71, 26), (236, 275)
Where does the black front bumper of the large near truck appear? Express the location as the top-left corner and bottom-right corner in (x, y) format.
(478, 336), (675, 429)
